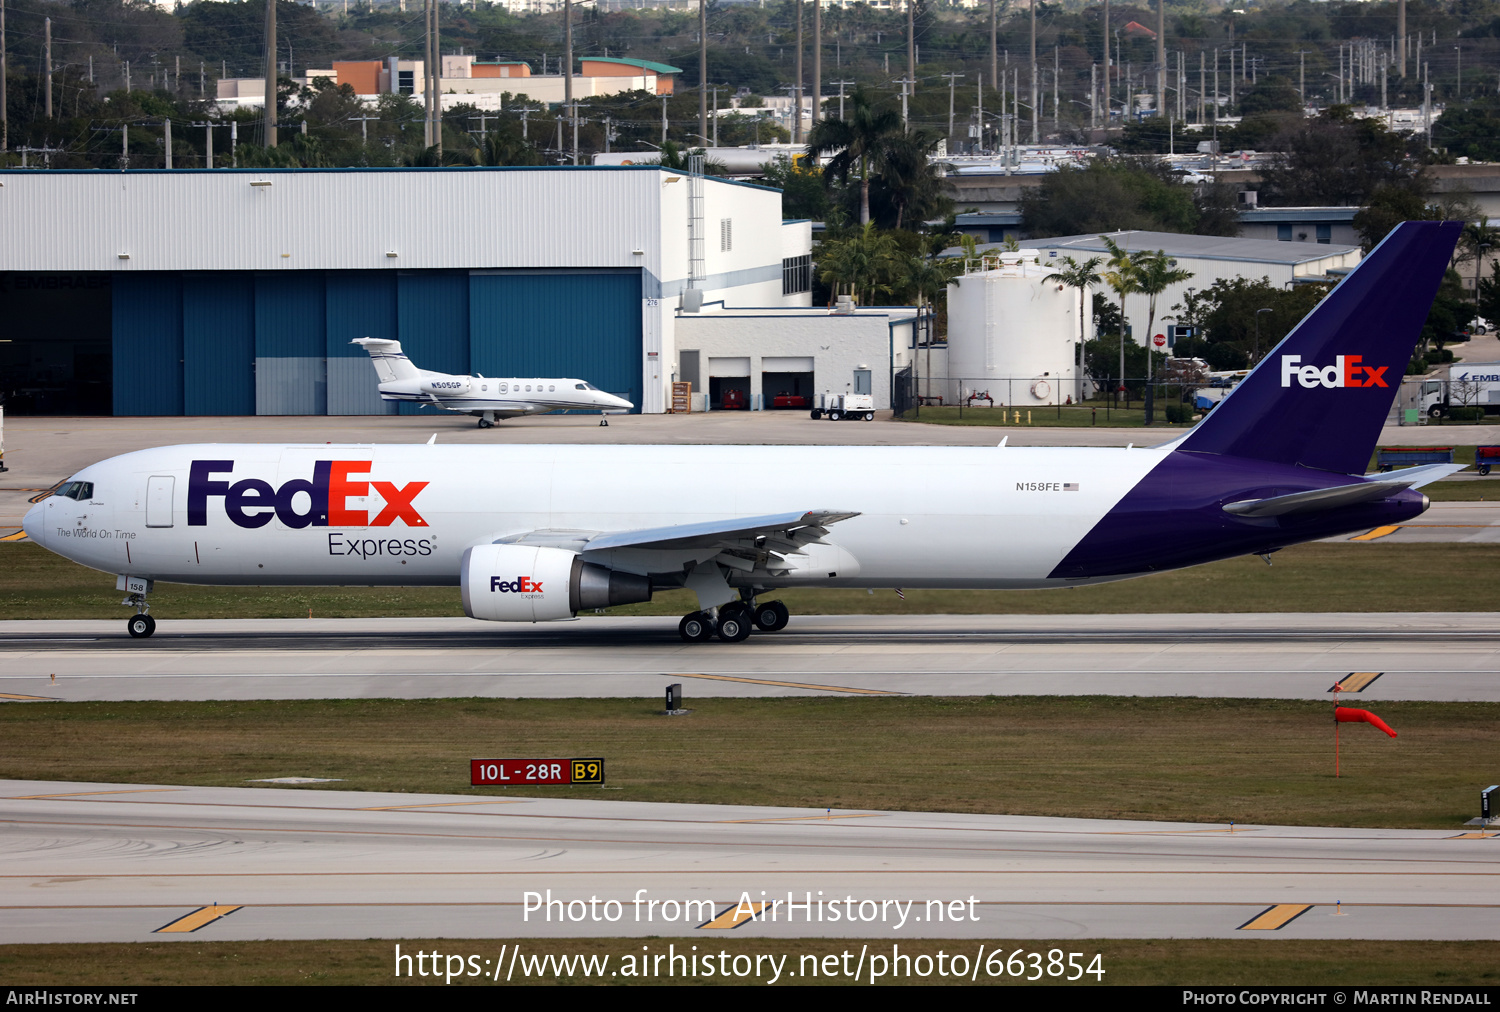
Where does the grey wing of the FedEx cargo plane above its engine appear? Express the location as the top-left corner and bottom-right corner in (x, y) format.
(501, 510), (860, 556)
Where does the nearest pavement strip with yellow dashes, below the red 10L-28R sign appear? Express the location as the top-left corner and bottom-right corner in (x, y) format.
(0, 779), (1500, 947)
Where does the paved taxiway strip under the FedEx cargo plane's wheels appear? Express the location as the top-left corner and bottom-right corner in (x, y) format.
(0, 612), (1500, 700)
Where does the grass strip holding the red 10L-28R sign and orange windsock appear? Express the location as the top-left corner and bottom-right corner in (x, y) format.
(0, 695), (1500, 834)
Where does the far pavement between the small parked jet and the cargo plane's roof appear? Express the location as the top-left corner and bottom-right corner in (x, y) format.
(0, 413), (1500, 531)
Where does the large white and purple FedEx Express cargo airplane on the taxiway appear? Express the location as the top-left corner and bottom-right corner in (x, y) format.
(26, 222), (1461, 642)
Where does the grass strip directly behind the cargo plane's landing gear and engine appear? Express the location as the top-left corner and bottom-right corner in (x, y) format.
(0, 541), (1500, 622)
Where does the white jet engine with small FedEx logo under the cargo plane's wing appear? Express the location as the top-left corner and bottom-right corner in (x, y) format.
(459, 544), (651, 622)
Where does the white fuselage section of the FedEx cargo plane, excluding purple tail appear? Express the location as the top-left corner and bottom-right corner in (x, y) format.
(26, 444), (1167, 588)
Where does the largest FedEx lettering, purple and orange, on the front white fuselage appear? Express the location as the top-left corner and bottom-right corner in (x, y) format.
(188, 460), (428, 529)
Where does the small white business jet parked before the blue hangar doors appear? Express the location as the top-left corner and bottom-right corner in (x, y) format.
(350, 337), (635, 429)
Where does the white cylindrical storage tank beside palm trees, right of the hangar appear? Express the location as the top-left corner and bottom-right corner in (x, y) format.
(948, 249), (1094, 408)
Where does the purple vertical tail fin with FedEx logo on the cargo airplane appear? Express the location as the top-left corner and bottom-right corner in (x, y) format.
(1176, 222), (1463, 474)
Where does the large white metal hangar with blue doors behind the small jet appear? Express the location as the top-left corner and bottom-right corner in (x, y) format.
(0, 165), (812, 415)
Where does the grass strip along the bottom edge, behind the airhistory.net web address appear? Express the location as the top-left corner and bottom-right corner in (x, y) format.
(0, 936), (1500, 987)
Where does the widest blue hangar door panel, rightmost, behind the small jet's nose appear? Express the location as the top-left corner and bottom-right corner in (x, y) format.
(470, 268), (642, 412)
